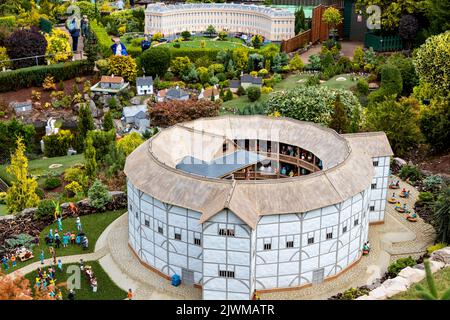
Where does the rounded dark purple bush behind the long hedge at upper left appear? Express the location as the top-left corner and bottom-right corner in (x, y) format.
(5, 27), (47, 68)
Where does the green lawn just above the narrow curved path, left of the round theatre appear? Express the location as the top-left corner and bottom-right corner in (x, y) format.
(1, 209), (126, 273)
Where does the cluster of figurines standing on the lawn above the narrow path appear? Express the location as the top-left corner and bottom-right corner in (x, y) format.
(45, 217), (89, 250)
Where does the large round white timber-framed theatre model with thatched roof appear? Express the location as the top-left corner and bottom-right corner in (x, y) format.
(125, 116), (393, 299)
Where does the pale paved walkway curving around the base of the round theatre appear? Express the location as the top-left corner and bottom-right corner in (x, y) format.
(7, 177), (434, 300)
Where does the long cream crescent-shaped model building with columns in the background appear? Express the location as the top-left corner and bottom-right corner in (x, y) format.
(145, 3), (295, 41)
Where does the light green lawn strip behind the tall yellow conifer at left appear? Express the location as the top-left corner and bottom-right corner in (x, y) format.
(0, 154), (84, 183)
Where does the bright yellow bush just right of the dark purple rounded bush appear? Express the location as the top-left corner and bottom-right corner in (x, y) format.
(45, 29), (72, 63)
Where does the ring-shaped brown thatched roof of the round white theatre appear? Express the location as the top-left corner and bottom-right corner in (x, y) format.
(125, 116), (392, 228)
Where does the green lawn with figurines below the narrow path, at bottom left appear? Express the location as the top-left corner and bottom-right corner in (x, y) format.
(25, 261), (127, 300)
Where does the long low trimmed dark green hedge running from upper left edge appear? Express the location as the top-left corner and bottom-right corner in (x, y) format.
(0, 61), (90, 92)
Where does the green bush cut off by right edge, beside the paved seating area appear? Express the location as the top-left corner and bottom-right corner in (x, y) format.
(433, 187), (450, 243)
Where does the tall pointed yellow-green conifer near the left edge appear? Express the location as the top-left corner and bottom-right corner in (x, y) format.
(5, 137), (39, 213)
